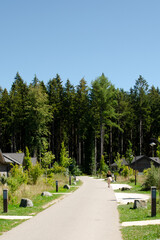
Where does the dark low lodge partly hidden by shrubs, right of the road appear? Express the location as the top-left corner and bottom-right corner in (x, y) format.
(111, 155), (160, 172)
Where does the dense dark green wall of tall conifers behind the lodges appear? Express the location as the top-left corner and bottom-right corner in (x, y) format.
(0, 73), (160, 173)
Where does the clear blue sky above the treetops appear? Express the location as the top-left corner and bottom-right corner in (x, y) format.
(0, 0), (160, 91)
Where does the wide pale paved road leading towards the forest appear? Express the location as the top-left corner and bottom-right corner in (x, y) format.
(0, 177), (122, 240)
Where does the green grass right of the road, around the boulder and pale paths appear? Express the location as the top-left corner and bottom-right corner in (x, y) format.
(116, 177), (160, 240)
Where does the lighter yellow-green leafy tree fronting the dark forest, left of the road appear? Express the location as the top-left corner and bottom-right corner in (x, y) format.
(27, 78), (52, 159)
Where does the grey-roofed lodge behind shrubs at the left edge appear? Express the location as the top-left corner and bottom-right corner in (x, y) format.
(0, 150), (37, 176)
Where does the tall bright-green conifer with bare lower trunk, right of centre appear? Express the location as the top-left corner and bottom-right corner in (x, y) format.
(91, 74), (118, 166)
